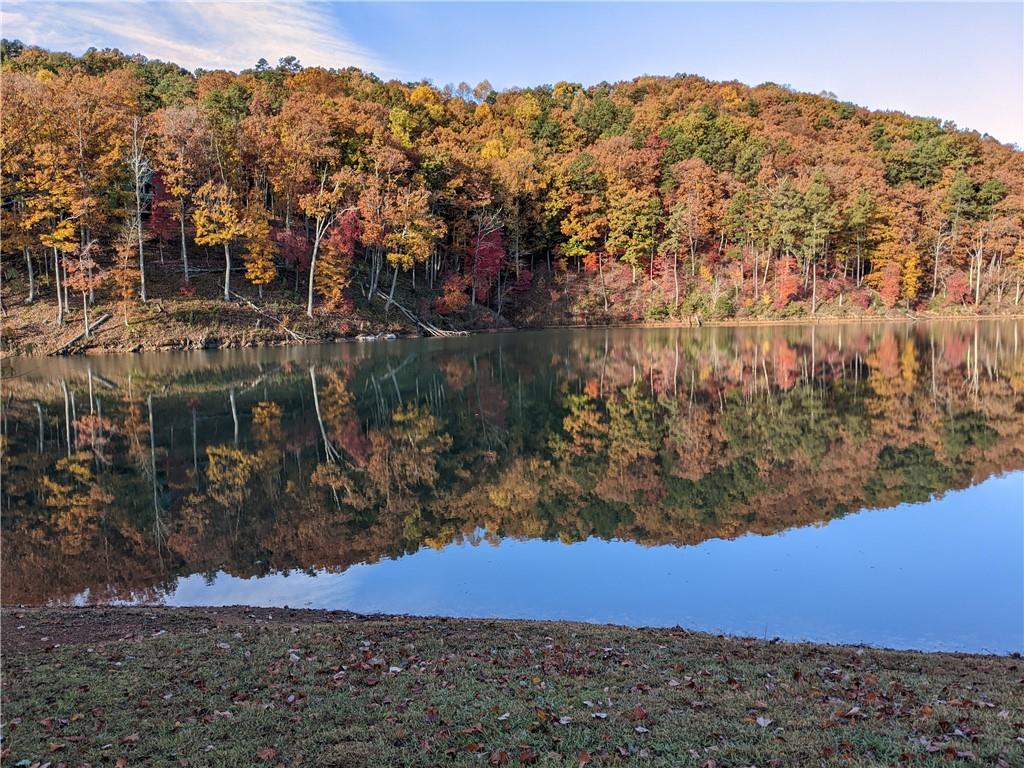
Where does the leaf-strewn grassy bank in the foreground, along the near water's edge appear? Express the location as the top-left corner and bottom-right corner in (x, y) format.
(2, 608), (1024, 768)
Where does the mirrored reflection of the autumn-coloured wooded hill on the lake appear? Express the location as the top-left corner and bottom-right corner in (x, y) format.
(2, 322), (1024, 604)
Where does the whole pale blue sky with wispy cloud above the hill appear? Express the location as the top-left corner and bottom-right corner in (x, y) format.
(6, 0), (1024, 146)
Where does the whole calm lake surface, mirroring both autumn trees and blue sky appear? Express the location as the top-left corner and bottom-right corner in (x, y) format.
(2, 322), (1024, 652)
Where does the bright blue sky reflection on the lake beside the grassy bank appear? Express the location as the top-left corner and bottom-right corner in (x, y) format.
(166, 472), (1024, 653)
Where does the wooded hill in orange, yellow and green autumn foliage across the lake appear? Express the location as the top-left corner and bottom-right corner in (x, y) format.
(0, 41), (1024, 352)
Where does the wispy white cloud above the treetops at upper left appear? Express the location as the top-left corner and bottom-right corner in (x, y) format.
(0, 0), (388, 75)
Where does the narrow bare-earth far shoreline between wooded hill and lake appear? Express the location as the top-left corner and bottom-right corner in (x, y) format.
(8, 312), (1024, 359)
